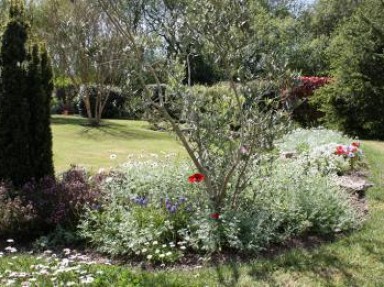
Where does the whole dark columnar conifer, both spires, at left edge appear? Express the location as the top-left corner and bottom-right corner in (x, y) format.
(0, 1), (53, 186)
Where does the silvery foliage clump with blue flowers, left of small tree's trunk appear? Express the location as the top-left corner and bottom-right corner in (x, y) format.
(80, 165), (207, 261)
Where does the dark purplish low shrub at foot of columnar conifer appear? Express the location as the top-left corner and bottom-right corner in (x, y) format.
(0, 168), (103, 240)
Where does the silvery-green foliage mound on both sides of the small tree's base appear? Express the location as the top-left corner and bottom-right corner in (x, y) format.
(79, 153), (358, 263)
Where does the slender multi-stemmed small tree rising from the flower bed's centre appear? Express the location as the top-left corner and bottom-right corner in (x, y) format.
(98, 0), (292, 213)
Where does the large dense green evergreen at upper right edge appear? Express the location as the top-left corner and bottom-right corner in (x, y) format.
(313, 1), (384, 139)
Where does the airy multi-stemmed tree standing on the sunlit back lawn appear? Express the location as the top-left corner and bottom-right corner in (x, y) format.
(39, 0), (130, 126)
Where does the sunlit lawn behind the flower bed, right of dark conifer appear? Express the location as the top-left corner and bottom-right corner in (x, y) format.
(52, 115), (185, 172)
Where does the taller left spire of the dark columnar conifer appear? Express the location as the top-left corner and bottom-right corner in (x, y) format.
(0, 2), (32, 188)
